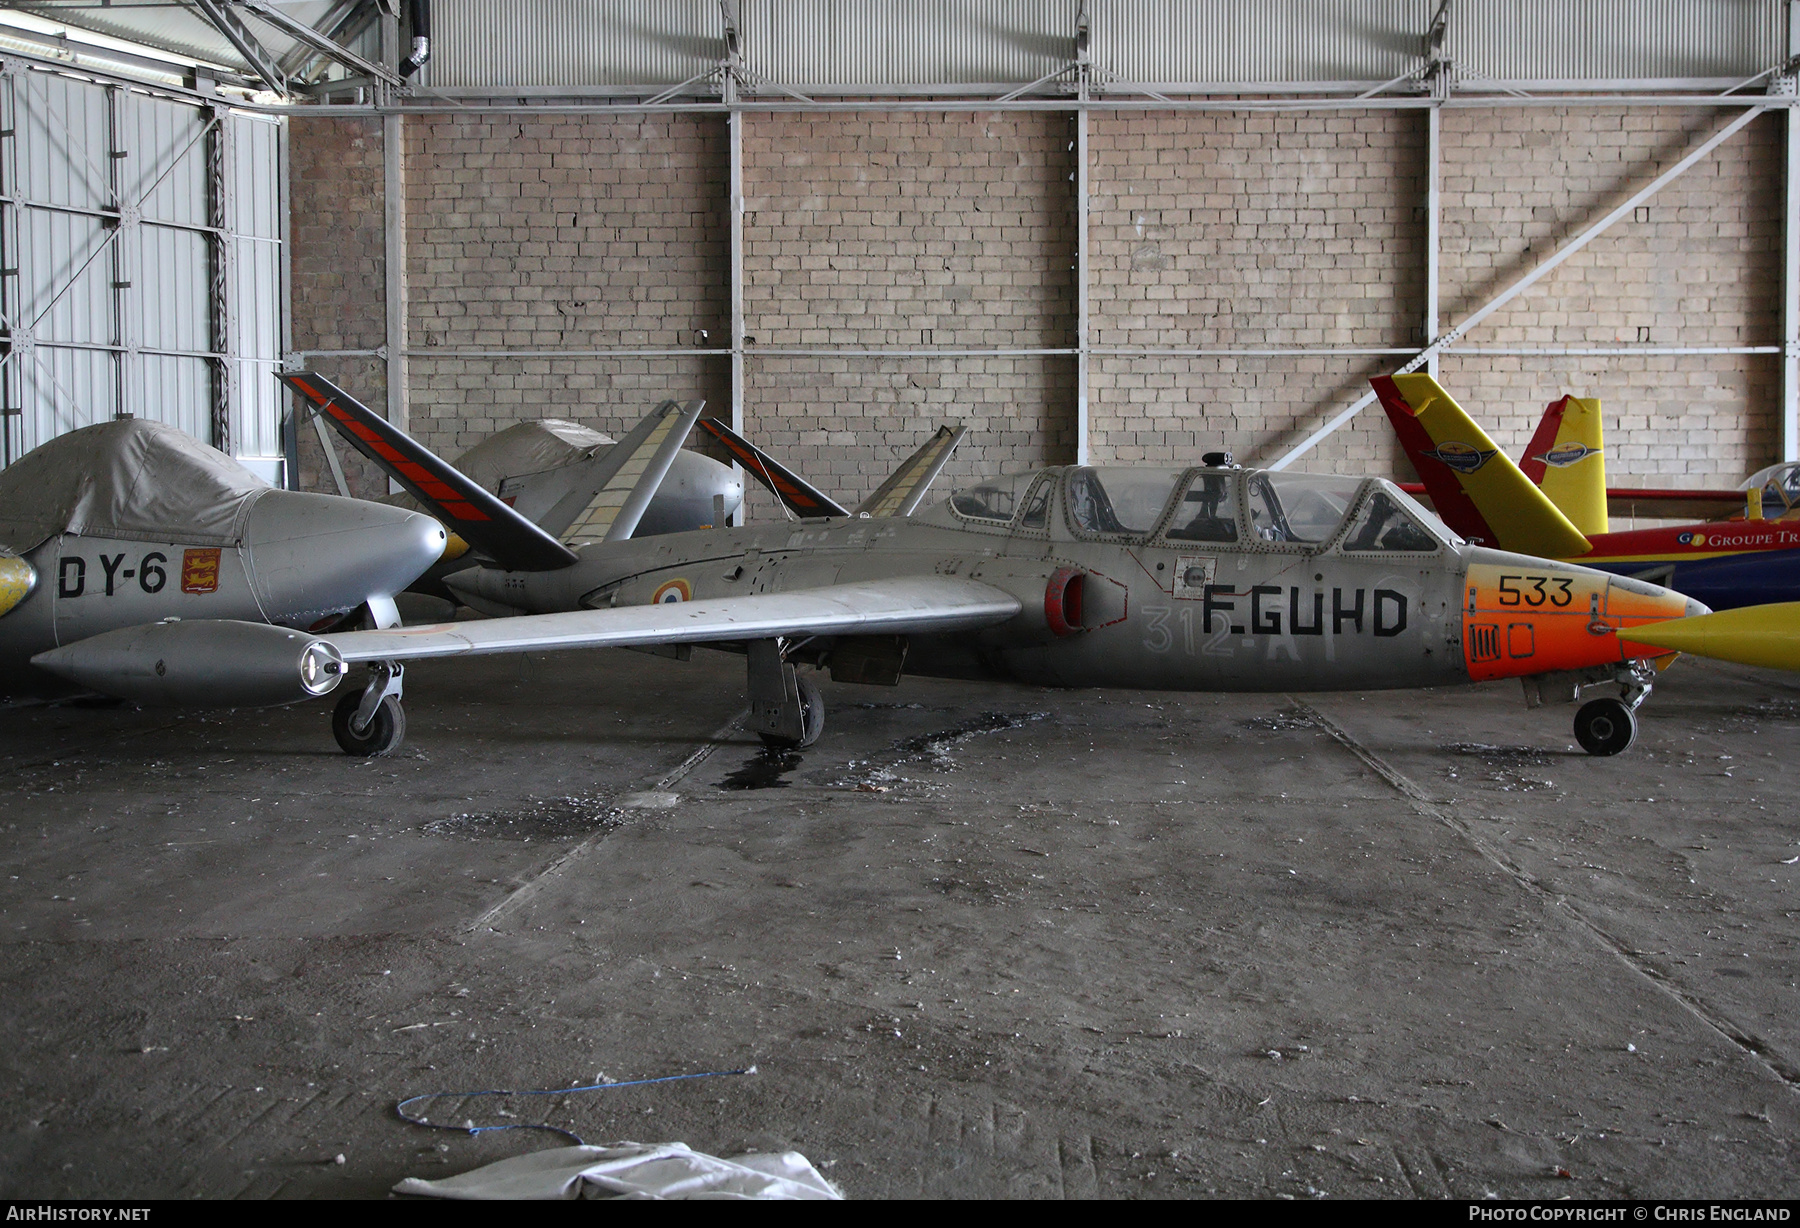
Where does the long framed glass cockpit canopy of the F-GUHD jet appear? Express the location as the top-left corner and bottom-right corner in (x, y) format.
(941, 465), (1454, 553)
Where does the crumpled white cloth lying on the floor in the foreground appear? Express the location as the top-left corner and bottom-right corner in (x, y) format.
(394, 1143), (842, 1199)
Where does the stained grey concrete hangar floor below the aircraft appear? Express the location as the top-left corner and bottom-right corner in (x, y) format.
(0, 652), (1800, 1197)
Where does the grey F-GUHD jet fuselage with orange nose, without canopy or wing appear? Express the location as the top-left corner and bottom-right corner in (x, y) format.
(454, 471), (1701, 691)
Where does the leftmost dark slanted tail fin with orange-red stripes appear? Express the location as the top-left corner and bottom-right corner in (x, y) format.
(275, 371), (576, 571)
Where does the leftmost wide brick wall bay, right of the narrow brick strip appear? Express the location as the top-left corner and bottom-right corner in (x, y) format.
(407, 115), (731, 454)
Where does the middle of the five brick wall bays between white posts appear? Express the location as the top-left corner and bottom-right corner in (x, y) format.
(743, 112), (1075, 504)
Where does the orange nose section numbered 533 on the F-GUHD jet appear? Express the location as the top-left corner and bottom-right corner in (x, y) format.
(1463, 551), (1705, 682)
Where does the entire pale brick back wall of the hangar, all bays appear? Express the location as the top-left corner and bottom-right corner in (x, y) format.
(293, 100), (1782, 515)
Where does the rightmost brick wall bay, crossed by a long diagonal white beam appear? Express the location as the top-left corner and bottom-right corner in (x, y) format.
(1440, 108), (1782, 486)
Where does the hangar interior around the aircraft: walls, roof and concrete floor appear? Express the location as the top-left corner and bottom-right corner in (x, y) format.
(0, 0), (1800, 1197)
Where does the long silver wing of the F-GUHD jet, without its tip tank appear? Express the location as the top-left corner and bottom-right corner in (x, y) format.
(319, 576), (1021, 661)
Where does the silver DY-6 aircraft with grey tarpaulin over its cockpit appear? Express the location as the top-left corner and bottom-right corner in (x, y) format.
(0, 418), (445, 706)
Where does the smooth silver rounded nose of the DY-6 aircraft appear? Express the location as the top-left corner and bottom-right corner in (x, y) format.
(245, 490), (448, 627)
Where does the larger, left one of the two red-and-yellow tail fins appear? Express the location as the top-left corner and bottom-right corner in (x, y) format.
(1370, 375), (1593, 558)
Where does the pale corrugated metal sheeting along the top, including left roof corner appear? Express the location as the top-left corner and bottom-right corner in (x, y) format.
(9, 0), (1786, 94)
